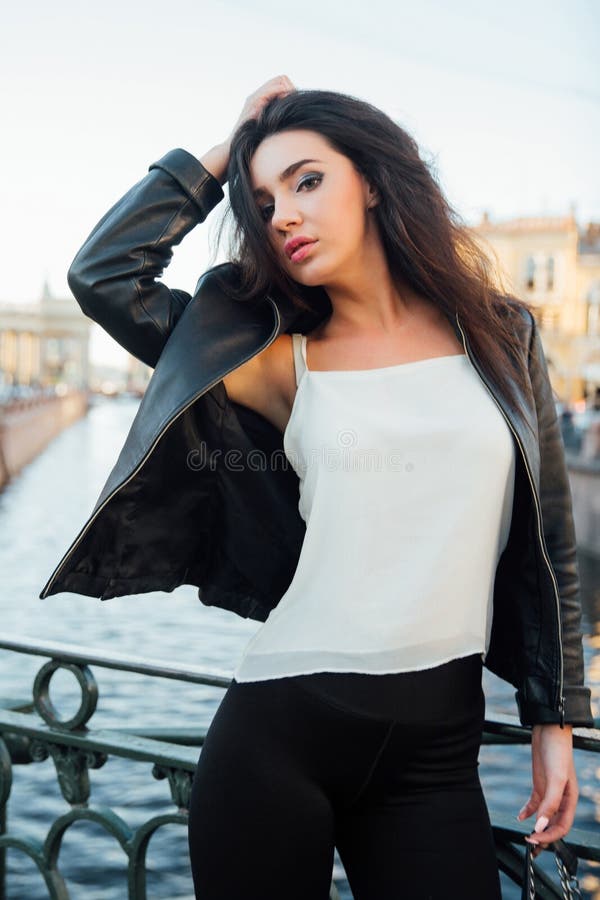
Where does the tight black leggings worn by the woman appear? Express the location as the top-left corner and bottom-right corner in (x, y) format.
(189, 654), (501, 900)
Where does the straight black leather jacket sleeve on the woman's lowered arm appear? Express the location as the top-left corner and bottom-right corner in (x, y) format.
(526, 316), (594, 727)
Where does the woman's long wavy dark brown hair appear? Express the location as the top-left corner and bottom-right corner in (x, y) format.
(215, 90), (533, 414)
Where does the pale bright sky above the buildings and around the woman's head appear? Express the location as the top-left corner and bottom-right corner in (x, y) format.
(0, 0), (600, 363)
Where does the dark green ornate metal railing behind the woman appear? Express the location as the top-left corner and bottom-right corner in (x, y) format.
(0, 636), (600, 900)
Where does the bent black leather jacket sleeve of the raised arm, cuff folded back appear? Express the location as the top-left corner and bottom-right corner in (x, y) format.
(67, 149), (224, 367)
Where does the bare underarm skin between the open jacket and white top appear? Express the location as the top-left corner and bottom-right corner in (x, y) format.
(223, 334), (295, 432)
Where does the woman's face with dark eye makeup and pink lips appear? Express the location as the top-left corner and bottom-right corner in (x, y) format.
(250, 129), (376, 286)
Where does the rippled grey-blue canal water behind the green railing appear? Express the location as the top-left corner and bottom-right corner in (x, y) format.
(0, 399), (600, 900)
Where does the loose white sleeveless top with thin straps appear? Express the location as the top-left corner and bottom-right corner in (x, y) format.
(234, 334), (515, 682)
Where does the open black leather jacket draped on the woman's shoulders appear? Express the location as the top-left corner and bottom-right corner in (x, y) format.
(40, 149), (593, 726)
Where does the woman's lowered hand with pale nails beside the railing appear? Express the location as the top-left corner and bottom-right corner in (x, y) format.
(517, 725), (579, 857)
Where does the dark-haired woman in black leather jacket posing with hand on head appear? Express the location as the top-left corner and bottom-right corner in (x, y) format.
(41, 77), (593, 900)
